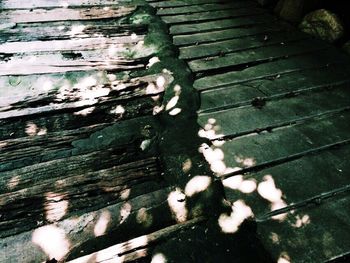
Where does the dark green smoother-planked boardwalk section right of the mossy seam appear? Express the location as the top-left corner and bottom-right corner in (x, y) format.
(151, 0), (350, 262)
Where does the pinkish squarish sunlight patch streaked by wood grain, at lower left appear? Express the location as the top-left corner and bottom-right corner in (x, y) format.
(45, 192), (69, 222)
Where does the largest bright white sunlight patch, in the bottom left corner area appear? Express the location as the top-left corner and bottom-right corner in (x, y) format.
(32, 225), (70, 260)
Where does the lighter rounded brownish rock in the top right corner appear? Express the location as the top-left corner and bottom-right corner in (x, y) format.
(299, 9), (345, 43)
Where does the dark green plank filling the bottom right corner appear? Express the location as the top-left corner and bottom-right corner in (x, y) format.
(258, 195), (350, 262)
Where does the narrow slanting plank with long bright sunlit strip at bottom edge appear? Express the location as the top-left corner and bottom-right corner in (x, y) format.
(69, 217), (205, 263)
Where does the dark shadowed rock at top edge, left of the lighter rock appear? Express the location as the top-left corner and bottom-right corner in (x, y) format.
(275, 0), (321, 23)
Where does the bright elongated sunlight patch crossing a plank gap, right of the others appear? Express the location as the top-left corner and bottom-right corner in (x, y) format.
(258, 175), (287, 221)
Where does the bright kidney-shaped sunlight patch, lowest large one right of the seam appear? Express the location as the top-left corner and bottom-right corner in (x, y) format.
(218, 200), (253, 234)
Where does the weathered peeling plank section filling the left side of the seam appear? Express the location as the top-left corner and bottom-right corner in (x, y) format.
(0, 0), (172, 262)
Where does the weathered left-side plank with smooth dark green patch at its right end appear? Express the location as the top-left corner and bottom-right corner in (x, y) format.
(0, 113), (158, 171)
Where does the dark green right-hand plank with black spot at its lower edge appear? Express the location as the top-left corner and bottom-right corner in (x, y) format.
(199, 65), (350, 113)
